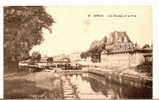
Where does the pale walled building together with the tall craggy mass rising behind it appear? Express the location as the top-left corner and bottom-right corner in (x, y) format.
(101, 31), (152, 67)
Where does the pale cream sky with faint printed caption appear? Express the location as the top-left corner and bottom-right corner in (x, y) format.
(30, 6), (153, 56)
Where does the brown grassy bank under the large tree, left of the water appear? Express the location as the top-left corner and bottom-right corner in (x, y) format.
(4, 71), (63, 99)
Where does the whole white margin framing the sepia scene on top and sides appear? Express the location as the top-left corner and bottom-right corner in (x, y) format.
(0, 0), (159, 99)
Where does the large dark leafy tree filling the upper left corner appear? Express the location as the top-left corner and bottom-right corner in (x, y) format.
(4, 6), (54, 71)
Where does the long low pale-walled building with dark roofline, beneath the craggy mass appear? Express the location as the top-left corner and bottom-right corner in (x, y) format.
(101, 43), (152, 67)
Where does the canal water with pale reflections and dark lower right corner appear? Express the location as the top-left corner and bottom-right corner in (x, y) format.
(62, 73), (152, 99)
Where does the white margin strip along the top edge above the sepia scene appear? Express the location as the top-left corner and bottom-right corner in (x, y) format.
(1, 0), (153, 6)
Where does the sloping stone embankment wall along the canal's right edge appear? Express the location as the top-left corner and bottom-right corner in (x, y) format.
(87, 67), (152, 88)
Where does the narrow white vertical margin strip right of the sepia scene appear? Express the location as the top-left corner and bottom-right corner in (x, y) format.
(153, 3), (159, 99)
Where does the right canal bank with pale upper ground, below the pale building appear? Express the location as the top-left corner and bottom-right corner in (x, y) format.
(79, 63), (152, 88)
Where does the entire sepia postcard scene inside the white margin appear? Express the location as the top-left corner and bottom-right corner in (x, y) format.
(4, 6), (153, 100)
